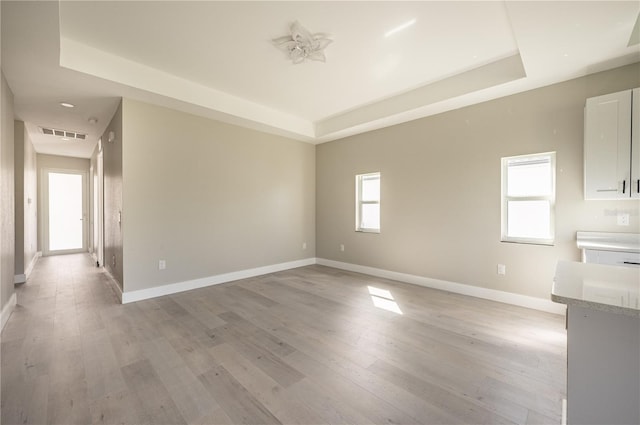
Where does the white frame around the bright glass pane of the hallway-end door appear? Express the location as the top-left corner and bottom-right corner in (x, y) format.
(40, 168), (89, 256)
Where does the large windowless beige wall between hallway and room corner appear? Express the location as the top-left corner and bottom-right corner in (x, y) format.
(122, 99), (315, 292)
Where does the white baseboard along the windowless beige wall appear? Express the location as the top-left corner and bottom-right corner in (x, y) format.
(122, 258), (316, 304)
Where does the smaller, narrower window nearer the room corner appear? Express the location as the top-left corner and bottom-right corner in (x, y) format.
(356, 173), (380, 233)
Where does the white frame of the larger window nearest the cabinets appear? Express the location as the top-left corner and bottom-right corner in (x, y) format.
(500, 152), (556, 245)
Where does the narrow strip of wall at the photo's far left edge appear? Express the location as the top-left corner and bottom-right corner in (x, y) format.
(0, 72), (15, 316)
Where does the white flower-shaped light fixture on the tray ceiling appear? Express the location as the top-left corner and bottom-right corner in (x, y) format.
(272, 21), (333, 64)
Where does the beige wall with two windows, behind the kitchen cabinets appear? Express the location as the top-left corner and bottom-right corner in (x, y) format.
(316, 64), (640, 299)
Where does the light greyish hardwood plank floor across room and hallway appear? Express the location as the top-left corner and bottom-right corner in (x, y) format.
(1, 254), (566, 425)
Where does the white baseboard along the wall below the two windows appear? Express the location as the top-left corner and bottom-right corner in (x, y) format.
(316, 258), (566, 314)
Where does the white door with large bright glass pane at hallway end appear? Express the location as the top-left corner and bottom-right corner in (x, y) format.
(43, 170), (87, 255)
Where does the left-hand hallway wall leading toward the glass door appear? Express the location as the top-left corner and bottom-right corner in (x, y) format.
(14, 121), (38, 279)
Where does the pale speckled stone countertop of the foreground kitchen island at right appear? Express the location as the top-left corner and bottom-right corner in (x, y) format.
(551, 261), (640, 317)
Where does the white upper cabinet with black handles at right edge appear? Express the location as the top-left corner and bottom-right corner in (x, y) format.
(584, 89), (640, 199)
